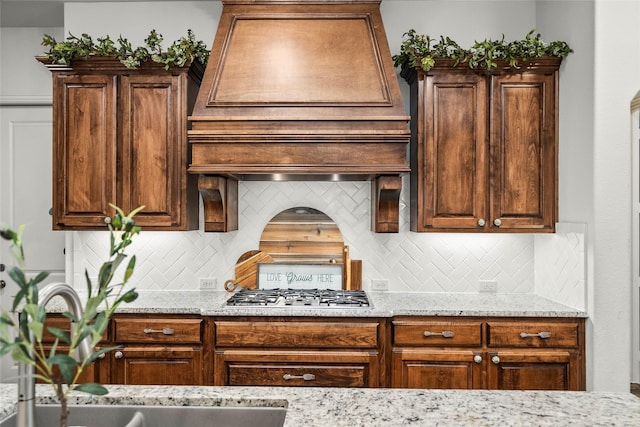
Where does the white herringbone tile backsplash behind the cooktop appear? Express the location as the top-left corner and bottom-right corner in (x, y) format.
(73, 177), (584, 305)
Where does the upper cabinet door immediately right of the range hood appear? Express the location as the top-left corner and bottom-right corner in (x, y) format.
(417, 72), (488, 231)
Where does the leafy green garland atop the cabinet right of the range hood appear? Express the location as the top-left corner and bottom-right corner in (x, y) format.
(393, 29), (573, 72)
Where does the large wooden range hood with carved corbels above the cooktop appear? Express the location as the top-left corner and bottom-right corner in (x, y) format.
(188, 0), (410, 232)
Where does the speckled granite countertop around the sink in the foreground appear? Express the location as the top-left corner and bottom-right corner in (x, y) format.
(0, 384), (640, 427)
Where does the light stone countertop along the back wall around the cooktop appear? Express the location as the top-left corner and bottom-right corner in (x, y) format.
(42, 290), (587, 318)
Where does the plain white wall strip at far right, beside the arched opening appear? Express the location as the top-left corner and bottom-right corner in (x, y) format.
(589, 1), (640, 390)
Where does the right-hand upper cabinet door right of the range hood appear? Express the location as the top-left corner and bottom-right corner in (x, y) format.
(489, 72), (557, 231)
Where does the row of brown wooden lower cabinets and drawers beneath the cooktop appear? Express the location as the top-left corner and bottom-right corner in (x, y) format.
(43, 314), (586, 390)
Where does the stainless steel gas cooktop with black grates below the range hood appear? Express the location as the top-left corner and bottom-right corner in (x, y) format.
(227, 289), (371, 308)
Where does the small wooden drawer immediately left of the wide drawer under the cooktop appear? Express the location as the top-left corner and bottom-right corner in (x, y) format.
(113, 318), (202, 344)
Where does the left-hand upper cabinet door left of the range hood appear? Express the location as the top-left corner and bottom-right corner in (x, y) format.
(53, 74), (116, 229)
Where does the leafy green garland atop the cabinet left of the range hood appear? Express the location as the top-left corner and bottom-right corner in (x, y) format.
(41, 29), (209, 70)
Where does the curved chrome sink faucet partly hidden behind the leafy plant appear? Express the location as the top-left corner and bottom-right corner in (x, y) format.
(16, 283), (92, 427)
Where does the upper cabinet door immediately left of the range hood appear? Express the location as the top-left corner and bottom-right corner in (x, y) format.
(120, 74), (182, 226)
